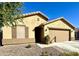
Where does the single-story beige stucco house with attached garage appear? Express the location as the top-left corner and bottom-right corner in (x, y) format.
(2, 12), (75, 44)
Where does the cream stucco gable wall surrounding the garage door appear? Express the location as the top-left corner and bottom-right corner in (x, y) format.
(44, 20), (75, 40)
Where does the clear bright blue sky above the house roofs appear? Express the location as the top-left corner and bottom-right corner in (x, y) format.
(22, 2), (79, 27)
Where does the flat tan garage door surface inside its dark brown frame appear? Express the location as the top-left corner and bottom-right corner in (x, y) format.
(49, 30), (69, 42)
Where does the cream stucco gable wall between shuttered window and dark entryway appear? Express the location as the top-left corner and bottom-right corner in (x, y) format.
(24, 15), (46, 38)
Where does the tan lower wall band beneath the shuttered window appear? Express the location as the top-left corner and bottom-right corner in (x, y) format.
(2, 38), (35, 45)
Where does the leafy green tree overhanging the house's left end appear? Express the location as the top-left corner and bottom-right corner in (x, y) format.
(0, 2), (22, 45)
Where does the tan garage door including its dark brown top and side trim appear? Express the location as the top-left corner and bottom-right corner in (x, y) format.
(49, 28), (71, 42)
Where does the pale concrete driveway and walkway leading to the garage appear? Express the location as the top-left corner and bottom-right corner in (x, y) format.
(37, 41), (79, 52)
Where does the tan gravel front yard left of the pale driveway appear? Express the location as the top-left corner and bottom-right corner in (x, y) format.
(0, 44), (65, 56)
